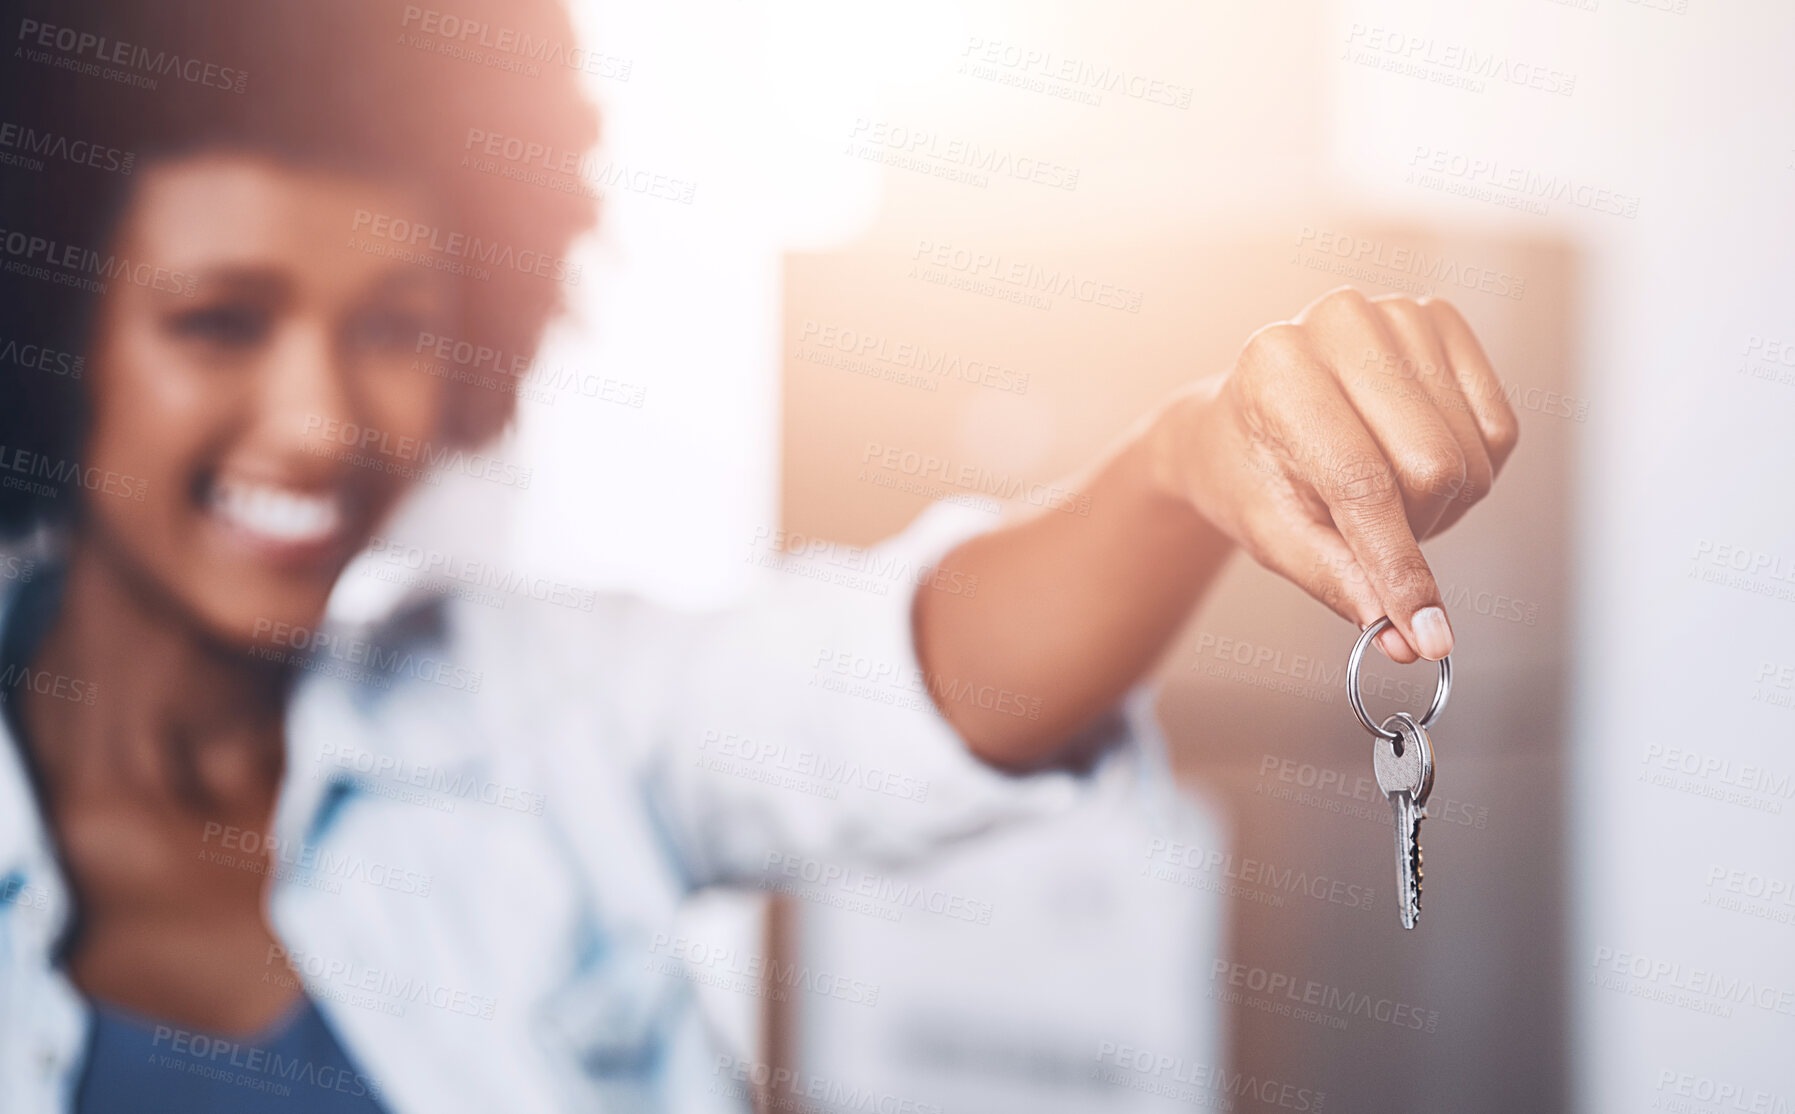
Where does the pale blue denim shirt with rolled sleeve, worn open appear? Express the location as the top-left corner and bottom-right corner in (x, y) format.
(0, 506), (1151, 1114)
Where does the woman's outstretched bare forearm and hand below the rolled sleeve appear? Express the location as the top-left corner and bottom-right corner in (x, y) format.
(914, 281), (1519, 770)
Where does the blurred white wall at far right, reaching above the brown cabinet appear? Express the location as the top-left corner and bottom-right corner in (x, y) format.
(1332, 0), (1795, 1112)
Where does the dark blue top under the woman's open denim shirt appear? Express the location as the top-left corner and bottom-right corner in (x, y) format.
(75, 997), (382, 1114)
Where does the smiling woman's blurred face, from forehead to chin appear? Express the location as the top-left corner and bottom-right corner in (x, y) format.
(79, 154), (454, 646)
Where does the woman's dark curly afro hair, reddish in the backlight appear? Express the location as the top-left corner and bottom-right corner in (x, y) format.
(0, 0), (610, 535)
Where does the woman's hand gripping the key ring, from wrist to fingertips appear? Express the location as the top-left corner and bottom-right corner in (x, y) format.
(1149, 287), (1520, 662)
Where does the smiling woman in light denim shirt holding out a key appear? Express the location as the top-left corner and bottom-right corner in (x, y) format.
(0, 0), (1517, 1114)
